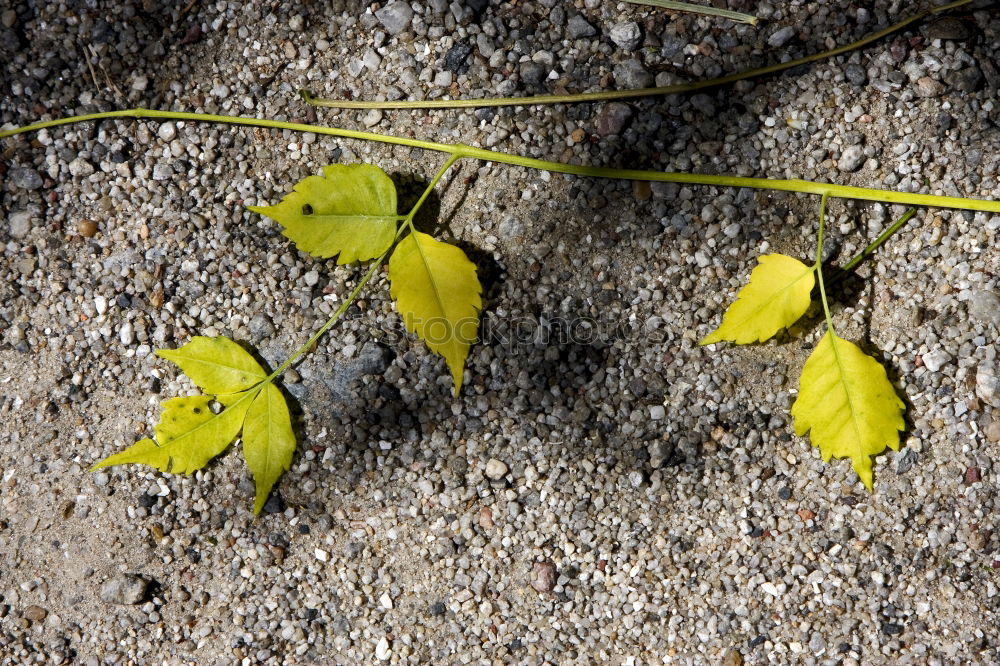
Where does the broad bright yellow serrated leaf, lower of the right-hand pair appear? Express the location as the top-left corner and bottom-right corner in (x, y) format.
(792, 330), (905, 490)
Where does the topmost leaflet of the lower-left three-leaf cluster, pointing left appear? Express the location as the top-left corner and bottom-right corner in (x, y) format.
(156, 335), (267, 394)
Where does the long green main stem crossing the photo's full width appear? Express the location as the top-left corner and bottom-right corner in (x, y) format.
(0, 108), (1000, 213)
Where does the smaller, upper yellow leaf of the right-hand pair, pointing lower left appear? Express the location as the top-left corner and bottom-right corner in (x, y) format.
(701, 254), (816, 345)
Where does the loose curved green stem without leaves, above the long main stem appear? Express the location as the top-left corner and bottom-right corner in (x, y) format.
(299, 0), (973, 109)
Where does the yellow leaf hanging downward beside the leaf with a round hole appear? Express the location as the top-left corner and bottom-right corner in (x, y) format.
(389, 231), (483, 395)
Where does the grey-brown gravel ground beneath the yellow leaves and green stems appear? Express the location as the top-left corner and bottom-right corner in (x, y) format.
(0, 0), (1000, 666)
